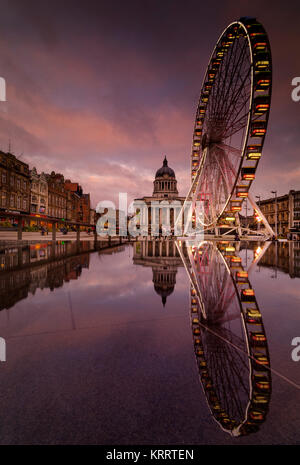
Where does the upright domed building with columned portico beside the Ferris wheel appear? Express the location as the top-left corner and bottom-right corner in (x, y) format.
(135, 157), (185, 228)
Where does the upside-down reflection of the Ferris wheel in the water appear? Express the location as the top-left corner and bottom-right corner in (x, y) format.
(179, 242), (271, 436)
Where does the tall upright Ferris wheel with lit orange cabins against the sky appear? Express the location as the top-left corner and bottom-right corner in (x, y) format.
(188, 18), (272, 227)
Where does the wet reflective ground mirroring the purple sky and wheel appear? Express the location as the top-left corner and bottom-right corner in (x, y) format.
(0, 241), (300, 445)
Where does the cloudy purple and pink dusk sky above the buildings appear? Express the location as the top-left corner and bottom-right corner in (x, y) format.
(0, 0), (300, 206)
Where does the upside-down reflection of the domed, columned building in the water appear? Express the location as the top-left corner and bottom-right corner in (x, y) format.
(133, 239), (183, 306)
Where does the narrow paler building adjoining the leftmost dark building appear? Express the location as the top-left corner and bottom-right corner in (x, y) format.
(30, 168), (48, 215)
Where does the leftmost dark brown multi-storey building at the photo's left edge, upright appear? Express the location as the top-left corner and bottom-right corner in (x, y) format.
(0, 151), (30, 214)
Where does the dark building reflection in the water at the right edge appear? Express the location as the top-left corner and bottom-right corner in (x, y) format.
(259, 242), (300, 278)
